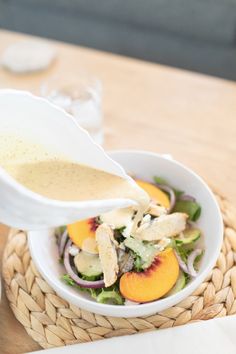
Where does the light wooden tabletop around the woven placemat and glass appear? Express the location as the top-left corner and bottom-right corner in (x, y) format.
(0, 31), (236, 354)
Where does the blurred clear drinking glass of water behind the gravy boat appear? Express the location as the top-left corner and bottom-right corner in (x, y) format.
(40, 72), (104, 144)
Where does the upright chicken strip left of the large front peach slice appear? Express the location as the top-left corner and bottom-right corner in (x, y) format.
(96, 223), (119, 287)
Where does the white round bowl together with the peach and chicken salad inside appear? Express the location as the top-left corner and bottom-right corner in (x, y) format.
(28, 150), (223, 317)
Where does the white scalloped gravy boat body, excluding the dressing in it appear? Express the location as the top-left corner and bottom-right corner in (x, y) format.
(0, 90), (139, 230)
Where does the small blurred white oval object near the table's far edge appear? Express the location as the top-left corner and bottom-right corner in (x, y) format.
(1, 40), (56, 73)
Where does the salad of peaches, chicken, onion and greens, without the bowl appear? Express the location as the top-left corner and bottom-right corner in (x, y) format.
(55, 176), (204, 305)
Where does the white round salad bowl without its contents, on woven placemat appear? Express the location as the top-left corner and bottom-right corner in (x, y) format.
(28, 150), (223, 317)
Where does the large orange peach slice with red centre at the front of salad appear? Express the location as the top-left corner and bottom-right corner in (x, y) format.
(120, 248), (179, 303)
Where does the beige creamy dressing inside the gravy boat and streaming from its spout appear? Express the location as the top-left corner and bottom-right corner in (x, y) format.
(0, 136), (149, 219)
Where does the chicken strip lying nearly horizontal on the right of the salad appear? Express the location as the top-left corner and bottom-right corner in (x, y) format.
(134, 213), (188, 241)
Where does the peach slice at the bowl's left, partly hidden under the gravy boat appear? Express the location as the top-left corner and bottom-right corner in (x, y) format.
(67, 218), (98, 254)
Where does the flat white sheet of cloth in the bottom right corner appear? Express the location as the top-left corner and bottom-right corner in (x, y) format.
(30, 316), (236, 354)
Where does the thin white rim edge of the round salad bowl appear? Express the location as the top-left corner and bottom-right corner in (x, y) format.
(28, 149), (224, 318)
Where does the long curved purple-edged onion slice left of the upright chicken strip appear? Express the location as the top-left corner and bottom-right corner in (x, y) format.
(64, 240), (105, 289)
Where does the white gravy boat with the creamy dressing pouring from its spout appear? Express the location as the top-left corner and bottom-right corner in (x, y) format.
(0, 90), (149, 229)
